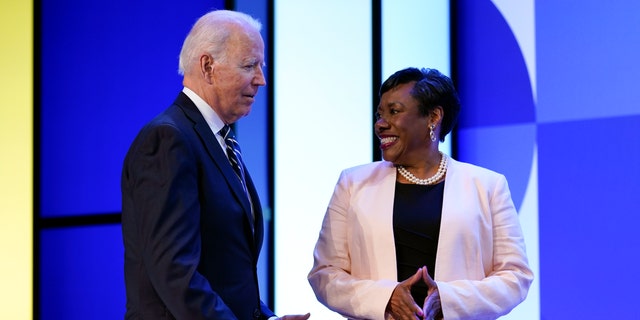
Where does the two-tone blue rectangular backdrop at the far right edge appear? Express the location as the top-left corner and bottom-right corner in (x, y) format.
(536, 0), (640, 319)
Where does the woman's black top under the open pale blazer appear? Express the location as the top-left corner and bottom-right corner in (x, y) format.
(393, 181), (444, 306)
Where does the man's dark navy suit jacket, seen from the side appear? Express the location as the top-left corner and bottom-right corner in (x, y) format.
(121, 93), (273, 320)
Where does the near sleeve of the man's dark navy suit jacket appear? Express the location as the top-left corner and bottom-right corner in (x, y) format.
(122, 125), (236, 319)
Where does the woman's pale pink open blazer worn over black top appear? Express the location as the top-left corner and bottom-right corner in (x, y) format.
(308, 158), (533, 320)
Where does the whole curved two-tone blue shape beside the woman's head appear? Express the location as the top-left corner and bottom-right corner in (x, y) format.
(455, 0), (536, 209)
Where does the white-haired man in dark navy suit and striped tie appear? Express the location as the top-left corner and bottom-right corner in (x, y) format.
(121, 10), (309, 320)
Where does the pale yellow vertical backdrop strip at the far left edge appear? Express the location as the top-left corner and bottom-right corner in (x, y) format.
(0, 0), (33, 319)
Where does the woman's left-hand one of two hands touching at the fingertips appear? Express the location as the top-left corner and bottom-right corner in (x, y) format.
(386, 268), (423, 320)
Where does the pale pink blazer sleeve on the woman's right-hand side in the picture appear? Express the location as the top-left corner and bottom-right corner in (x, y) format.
(436, 175), (533, 320)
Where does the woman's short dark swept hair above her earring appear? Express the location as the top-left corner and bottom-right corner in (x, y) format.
(379, 68), (460, 141)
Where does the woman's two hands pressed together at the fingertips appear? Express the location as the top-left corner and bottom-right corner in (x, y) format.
(386, 267), (443, 320)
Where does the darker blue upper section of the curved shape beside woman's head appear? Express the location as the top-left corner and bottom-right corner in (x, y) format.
(456, 0), (535, 128)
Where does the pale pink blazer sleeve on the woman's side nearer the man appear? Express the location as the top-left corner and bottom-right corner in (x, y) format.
(308, 171), (398, 319)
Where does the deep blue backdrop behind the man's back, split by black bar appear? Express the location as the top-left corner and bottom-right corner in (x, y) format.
(34, 0), (224, 320)
